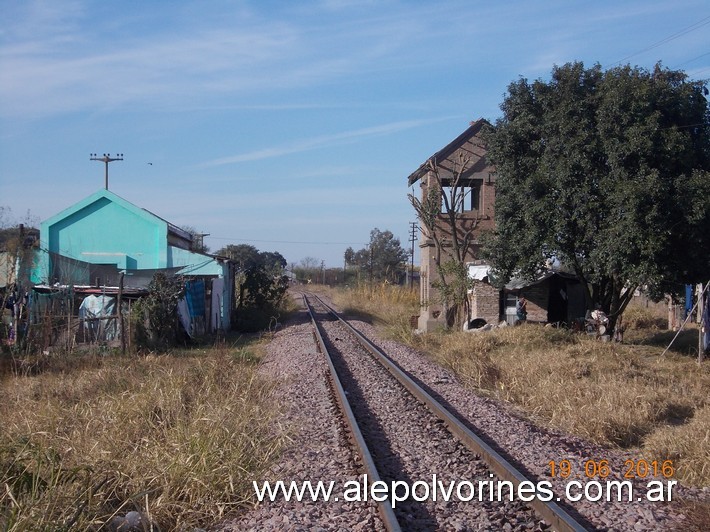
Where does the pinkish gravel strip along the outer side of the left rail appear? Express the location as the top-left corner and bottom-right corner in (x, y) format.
(222, 313), (384, 531)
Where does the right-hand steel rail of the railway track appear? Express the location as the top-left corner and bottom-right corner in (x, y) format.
(313, 294), (587, 532)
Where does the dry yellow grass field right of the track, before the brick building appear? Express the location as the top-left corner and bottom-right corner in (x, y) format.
(334, 293), (710, 486)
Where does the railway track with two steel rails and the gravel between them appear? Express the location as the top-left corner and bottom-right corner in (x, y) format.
(303, 294), (586, 531)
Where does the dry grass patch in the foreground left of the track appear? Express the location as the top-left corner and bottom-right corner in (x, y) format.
(0, 338), (280, 530)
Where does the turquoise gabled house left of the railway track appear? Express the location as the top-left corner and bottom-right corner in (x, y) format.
(33, 189), (233, 330)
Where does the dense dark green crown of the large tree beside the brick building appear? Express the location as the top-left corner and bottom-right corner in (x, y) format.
(487, 63), (710, 325)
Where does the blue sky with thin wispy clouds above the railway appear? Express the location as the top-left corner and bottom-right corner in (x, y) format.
(0, 0), (710, 266)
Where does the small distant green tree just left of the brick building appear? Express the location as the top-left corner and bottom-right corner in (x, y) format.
(344, 227), (409, 283)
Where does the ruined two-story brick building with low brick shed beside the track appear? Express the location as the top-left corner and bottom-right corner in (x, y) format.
(408, 120), (586, 331)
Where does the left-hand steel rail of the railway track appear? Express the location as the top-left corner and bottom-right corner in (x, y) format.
(302, 294), (401, 532)
